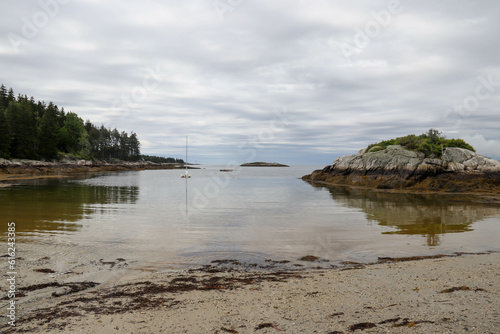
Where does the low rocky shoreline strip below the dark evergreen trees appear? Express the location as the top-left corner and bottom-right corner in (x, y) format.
(0, 159), (192, 181)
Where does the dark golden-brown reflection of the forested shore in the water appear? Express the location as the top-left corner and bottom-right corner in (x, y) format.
(0, 179), (139, 237)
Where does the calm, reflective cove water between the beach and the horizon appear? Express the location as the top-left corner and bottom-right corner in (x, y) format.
(0, 166), (500, 267)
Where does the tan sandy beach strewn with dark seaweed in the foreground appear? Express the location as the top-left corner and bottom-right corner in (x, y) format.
(0, 241), (500, 334)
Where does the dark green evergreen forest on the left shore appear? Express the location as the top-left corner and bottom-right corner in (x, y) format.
(0, 85), (142, 161)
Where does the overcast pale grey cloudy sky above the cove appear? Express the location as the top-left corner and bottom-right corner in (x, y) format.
(0, 0), (500, 165)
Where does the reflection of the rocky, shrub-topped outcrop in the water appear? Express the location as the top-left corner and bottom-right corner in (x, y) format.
(312, 186), (500, 246)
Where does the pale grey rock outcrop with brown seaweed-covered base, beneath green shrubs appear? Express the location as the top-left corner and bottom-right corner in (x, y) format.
(303, 145), (500, 192)
